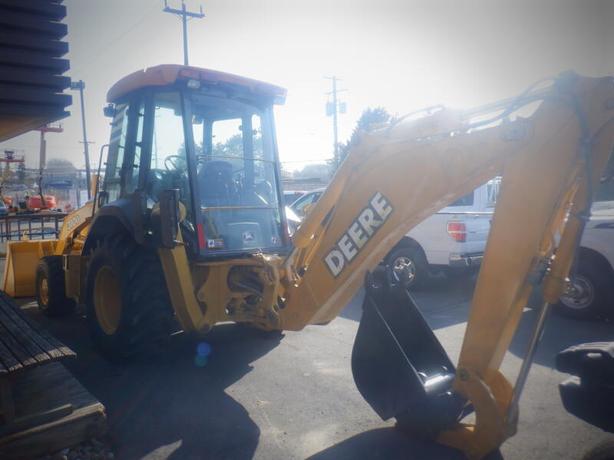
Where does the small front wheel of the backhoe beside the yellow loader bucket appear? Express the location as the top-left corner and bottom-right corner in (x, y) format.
(36, 256), (75, 316)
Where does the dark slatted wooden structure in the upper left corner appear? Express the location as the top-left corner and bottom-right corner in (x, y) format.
(0, 0), (72, 141)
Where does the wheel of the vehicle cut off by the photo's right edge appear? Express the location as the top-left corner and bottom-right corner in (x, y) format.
(556, 252), (614, 319)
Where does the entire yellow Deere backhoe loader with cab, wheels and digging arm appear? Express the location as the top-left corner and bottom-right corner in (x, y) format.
(4, 65), (614, 458)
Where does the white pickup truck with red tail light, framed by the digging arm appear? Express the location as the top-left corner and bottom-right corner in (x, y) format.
(385, 178), (501, 287)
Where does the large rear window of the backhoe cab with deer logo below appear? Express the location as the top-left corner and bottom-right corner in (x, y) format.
(192, 94), (283, 252)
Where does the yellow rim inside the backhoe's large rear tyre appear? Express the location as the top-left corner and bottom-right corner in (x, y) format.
(94, 266), (122, 335)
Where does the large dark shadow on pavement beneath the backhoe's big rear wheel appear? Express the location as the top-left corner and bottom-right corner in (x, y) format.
(20, 302), (281, 459)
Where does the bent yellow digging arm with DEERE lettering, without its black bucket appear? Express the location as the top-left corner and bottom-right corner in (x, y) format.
(280, 74), (614, 458)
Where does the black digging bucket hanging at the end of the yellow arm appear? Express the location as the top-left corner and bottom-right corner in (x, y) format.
(352, 270), (468, 435)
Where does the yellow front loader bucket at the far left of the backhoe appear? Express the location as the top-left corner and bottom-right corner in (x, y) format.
(2, 240), (56, 297)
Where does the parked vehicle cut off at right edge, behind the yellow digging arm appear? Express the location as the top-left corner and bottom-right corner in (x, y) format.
(556, 201), (614, 319)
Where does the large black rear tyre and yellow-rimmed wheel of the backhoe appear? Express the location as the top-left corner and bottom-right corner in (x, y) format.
(86, 235), (172, 359)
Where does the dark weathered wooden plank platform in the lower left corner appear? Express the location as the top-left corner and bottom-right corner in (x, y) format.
(0, 291), (105, 459)
